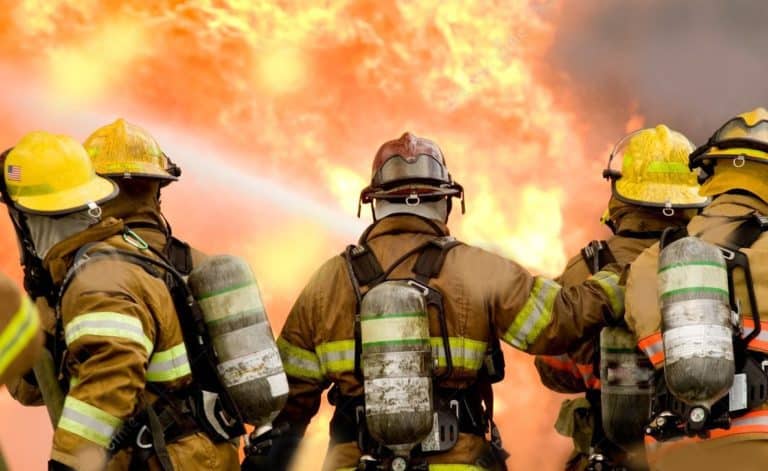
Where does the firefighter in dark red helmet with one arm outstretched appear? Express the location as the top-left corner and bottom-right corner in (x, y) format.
(243, 133), (623, 470)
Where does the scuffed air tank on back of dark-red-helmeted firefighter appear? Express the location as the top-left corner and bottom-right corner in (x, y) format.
(360, 281), (434, 456)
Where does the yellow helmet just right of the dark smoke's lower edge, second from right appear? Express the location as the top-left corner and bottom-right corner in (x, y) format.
(603, 124), (709, 214)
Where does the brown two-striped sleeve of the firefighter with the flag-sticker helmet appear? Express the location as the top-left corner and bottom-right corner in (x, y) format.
(51, 260), (162, 468)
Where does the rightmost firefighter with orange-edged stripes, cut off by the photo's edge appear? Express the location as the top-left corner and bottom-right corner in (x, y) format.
(626, 108), (768, 471)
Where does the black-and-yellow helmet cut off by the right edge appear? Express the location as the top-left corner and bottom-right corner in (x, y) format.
(689, 108), (768, 178)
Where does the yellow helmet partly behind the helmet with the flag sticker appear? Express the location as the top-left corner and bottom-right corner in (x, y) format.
(83, 118), (181, 184)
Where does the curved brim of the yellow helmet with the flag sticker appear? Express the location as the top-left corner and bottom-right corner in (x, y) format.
(14, 176), (119, 216)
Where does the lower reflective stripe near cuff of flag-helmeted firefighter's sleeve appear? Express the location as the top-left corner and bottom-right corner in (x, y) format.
(58, 396), (123, 448)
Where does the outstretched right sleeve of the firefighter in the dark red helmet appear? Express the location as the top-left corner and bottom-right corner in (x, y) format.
(482, 254), (624, 355)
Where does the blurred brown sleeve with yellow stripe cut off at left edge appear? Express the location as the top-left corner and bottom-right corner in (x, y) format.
(0, 275), (43, 385)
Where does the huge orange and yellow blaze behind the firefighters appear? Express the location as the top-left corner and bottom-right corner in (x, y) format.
(0, 0), (639, 469)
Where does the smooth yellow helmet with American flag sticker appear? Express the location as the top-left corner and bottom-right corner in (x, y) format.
(3, 131), (118, 216)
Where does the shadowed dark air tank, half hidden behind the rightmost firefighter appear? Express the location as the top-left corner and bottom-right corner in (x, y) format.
(600, 327), (654, 449)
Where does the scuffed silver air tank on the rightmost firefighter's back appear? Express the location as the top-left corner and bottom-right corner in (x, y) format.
(658, 237), (735, 429)
